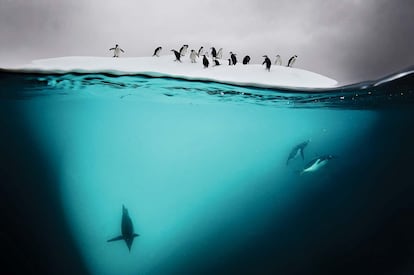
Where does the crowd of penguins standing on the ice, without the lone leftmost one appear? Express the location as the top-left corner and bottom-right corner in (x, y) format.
(152, 44), (298, 71)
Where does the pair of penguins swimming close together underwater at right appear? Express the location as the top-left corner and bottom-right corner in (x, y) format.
(286, 140), (337, 175)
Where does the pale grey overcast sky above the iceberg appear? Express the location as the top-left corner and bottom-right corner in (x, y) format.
(0, 0), (414, 84)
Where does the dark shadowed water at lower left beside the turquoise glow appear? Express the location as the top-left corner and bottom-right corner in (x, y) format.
(0, 102), (87, 274)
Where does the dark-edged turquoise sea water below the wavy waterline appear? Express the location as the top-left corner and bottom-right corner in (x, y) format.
(0, 70), (414, 274)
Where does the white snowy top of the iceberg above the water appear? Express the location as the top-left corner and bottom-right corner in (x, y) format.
(4, 55), (337, 88)
